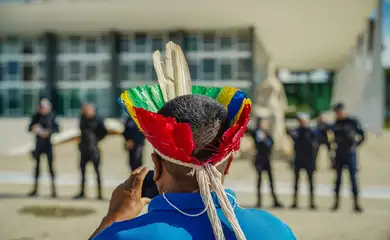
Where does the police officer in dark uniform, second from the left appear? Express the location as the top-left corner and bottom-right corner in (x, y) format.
(74, 103), (108, 200)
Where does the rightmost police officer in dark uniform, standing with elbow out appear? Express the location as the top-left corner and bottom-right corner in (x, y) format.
(332, 103), (365, 212)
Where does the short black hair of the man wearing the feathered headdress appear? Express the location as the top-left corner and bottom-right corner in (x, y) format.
(158, 95), (228, 161)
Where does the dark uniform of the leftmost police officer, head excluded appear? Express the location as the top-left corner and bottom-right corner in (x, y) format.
(28, 112), (59, 197)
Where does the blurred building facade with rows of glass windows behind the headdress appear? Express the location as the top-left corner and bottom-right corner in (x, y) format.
(0, 27), (255, 117)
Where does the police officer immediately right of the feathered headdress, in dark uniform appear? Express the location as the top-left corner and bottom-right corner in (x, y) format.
(252, 118), (283, 208)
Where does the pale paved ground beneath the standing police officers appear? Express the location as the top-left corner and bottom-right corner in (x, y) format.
(0, 133), (390, 240)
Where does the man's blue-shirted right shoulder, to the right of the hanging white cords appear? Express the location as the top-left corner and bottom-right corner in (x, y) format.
(236, 208), (296, 240)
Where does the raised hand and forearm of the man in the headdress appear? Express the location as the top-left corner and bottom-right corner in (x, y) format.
(89, 167), (150, 239)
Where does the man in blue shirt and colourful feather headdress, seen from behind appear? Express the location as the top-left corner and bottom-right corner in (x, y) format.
(91, 42), (295, 240)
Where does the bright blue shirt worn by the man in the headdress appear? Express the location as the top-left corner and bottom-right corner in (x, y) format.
(94, 190), (296, 240)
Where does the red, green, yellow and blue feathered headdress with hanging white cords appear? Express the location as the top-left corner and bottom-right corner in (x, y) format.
(118, 42), (251, 239)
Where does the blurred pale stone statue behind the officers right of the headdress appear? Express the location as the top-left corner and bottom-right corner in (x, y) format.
(254, 62), (292, 156)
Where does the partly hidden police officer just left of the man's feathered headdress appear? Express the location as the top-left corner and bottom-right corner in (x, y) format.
(123, 117), (145, 171)
